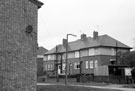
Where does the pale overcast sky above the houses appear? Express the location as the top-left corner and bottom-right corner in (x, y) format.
(38, 0), (135, 50)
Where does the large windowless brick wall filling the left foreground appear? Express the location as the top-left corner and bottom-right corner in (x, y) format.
(0, 0), (37, 91)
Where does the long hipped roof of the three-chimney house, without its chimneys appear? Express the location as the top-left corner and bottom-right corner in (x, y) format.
(45, 35), (132, 54)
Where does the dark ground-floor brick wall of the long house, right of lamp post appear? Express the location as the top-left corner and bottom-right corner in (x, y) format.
(63, 55), (115, 74)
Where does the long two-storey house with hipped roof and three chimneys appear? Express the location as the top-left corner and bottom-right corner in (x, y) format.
(44, 31), (131, 75)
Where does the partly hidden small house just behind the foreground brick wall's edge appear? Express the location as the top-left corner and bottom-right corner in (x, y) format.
(37, 47), (48, 76)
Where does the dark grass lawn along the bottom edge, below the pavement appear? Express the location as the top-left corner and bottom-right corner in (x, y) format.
(37, 85), (121, 91)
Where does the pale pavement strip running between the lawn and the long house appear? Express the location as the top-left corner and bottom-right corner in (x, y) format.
(37, 83), (135, 91)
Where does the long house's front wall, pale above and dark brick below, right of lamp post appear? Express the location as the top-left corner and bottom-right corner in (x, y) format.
(43, 47), (127, 74)
